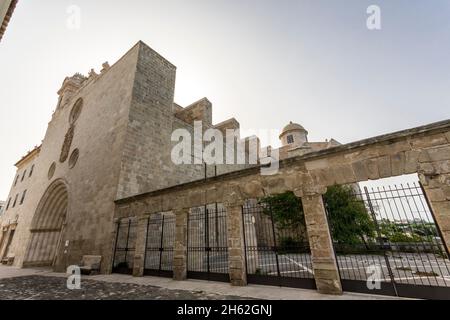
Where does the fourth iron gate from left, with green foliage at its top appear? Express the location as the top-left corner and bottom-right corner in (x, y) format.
(242, 203), (316, 289)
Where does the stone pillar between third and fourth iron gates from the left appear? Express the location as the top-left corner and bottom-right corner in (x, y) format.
(226, 203), (247, 286)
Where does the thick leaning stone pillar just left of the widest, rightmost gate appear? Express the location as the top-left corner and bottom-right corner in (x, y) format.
(302, 194), (342, 295)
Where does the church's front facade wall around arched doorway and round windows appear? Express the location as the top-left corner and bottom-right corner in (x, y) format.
(3, 40), (140, 271)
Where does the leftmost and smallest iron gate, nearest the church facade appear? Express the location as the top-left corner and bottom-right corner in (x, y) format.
(112, 218), (137, 274)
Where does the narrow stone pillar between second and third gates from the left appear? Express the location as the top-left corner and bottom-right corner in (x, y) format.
(173, 209), (189, 281)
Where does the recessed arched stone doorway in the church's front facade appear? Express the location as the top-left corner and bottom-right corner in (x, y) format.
(24, 180), (68, 267)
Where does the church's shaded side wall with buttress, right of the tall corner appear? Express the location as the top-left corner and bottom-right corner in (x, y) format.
(117, 45), (255, 199)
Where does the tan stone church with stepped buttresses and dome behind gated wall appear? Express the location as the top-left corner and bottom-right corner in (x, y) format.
(0, 42), (339, 272)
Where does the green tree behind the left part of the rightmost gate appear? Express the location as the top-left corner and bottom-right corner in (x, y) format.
(324, 185), (375, 248)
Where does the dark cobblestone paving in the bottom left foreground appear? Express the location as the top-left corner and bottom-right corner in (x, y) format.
(0, 276), (250, 300)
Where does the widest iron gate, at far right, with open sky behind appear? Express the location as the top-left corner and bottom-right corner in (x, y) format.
(324, 183), (450, 299)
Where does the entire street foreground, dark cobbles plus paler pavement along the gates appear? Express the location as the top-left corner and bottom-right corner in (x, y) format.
(0, 265), (396, 300)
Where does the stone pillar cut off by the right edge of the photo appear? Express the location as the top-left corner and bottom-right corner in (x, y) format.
(419, 172), (450, 252)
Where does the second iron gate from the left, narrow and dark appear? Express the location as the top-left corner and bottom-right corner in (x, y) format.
(144, 213), (175, 278)
